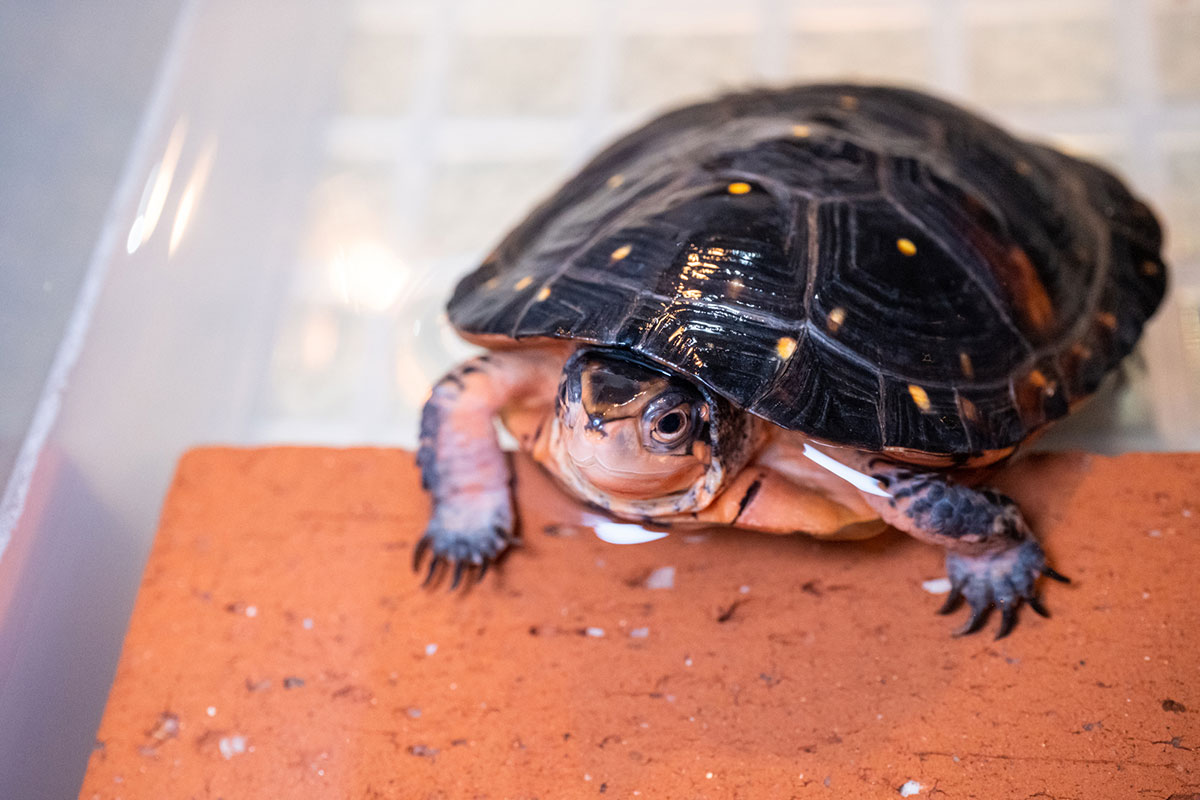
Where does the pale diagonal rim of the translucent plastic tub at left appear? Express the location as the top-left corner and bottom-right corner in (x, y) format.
(0, 0), (199, 558)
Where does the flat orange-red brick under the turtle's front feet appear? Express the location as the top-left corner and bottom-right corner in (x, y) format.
(80, 449), (1200, 799)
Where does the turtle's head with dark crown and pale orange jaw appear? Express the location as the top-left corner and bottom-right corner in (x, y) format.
(552, 349), (749, 517)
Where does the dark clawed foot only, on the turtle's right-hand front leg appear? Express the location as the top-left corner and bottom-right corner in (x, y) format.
(938, 539), (1069, 639)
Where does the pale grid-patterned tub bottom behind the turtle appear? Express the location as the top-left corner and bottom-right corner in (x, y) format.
(254, 0), (1200, 447)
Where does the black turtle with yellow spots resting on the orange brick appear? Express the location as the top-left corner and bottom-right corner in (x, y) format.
(413, 84), (1166, 638)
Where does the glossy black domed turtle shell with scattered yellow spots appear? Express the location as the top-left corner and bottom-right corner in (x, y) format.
(449, 85), (1166, 457)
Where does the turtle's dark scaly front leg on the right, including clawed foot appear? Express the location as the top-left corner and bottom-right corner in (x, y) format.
(869, 461), (1068, 639)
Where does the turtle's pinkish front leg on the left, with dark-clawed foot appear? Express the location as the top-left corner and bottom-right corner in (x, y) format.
(413, 349), (562, 589)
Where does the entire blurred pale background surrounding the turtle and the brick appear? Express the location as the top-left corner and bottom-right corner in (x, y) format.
(0, 0), (1200, 798)
